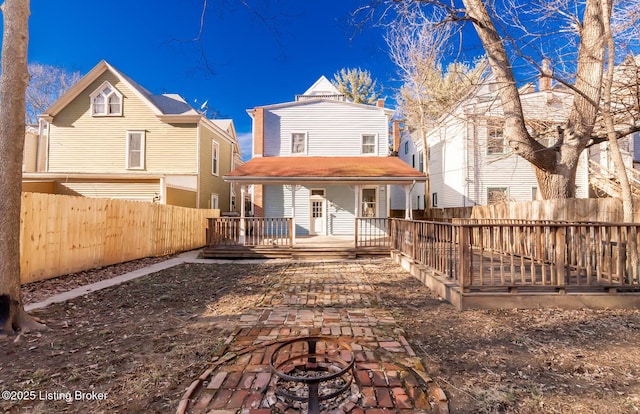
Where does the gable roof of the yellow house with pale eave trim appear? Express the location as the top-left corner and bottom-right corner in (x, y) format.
(40, 60), (200, 119)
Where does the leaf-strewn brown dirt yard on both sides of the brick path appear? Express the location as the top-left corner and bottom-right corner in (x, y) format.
(0, 259), (640, 413)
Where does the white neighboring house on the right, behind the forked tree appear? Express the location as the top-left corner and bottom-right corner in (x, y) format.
(392, 71), (589, 212)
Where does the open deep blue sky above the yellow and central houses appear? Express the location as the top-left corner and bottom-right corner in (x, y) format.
(29, 0), (397, 158)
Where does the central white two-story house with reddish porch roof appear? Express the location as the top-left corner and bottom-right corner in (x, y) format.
(224, 76), (425, 236)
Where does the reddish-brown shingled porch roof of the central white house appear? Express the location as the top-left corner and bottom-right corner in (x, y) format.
(224, 157), (426, 184)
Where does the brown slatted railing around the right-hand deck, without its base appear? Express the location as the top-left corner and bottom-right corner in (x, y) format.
(391, 220), (640, 291)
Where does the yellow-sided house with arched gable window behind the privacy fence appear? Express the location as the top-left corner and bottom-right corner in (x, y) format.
(23, 60), (240, 212)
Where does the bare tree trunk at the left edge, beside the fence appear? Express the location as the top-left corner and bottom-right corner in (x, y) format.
(0, 0), (42, 333)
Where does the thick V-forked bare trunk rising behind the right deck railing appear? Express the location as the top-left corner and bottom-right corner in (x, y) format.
(463, 0), (605, 199)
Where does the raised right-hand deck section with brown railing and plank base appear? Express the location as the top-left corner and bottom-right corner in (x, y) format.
(392, 220), (640, 310)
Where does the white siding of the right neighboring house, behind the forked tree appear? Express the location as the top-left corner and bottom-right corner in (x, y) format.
(422, 81), (588, 208)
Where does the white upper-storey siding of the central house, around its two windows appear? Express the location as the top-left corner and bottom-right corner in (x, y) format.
(264, 101), (389, 157)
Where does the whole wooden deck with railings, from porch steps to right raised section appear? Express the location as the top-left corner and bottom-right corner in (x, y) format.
(204, 218), (640, 310)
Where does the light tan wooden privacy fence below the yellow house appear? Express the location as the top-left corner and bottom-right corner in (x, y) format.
(20, 193), (220, 283)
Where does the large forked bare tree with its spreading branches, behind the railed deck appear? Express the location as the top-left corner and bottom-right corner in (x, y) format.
(378, 0), (640, 206)
